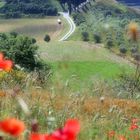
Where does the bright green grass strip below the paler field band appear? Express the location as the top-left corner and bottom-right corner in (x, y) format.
(51, 60), (131, 81)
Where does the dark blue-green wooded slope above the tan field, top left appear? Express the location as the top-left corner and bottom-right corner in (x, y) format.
(0, 0), (61, 18)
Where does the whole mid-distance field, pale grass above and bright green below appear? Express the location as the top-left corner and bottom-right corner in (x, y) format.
(39, 41), (133, 88)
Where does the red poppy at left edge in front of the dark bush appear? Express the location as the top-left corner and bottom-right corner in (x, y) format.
(0, 53), (13, 71)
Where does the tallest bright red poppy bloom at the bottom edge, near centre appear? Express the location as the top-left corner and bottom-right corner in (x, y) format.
(49, 119), (80, 140)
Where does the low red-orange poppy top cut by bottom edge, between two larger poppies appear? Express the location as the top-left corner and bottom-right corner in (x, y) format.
(29, 133), (49, 140)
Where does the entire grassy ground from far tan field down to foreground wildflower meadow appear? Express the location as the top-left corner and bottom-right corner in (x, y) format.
(0, 6), (140, 140)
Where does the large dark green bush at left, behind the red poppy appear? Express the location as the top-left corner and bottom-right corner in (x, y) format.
(0, 33), (49, 71)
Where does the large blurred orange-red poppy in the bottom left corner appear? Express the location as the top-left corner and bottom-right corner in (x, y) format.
(0, 118), (25, 137)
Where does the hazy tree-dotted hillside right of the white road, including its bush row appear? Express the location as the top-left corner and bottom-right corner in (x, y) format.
(73, 1), (140, 57)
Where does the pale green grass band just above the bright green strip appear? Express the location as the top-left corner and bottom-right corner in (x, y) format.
(39, 41), (130, 65)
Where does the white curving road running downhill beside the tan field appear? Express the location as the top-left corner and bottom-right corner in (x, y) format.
(59, 12), (76, 41)
